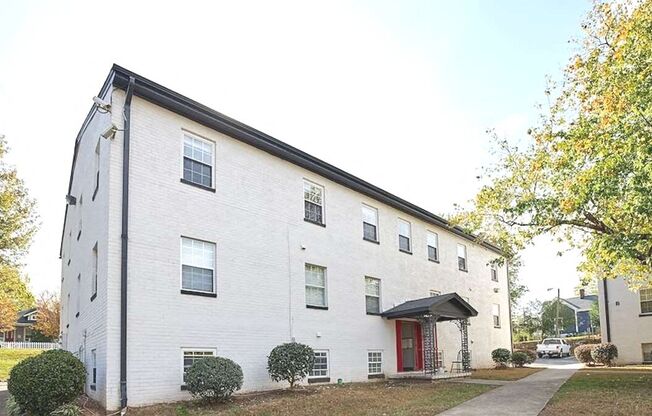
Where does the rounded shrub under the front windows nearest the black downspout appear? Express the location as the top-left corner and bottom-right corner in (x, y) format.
(186, 357), (243, 401)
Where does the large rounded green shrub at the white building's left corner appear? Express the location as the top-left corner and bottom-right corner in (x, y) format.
(7, 350), (86, 415)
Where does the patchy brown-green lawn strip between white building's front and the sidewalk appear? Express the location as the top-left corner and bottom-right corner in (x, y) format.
(129, 382), (492, 416)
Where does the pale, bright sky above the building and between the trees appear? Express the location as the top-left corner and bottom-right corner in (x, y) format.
(0, 0), (590, 306)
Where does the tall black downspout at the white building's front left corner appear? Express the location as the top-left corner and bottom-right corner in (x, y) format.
(120, 77), (136, 410)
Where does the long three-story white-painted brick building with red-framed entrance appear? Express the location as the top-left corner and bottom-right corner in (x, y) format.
(61, 66), (511, 409)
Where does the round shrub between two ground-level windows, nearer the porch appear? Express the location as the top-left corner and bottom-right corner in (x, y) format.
(267, 342), (315, 388)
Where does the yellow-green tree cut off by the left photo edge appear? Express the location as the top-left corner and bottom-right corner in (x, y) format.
(0, 136), (37, 265)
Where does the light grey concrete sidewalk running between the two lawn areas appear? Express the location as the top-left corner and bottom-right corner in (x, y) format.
(440, 369), (577, 416)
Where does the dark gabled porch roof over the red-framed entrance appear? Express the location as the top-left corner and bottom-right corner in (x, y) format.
(381, 293), (478, 321)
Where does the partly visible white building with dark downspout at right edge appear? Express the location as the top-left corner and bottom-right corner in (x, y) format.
(598, 278), (652, 364)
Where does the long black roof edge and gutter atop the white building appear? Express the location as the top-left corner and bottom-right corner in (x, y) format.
(107, 64), (504, 255)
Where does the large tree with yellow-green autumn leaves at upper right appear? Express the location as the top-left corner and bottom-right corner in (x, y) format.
(454, 0), (652, 289)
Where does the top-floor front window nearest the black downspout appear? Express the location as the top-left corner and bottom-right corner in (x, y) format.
(183, 134), (215, 188)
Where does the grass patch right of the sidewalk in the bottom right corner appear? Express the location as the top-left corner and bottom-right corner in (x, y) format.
(541, 368), (652, 416)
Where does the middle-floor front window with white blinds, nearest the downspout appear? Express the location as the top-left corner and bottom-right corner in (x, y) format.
(181, 237), (215, 293)
